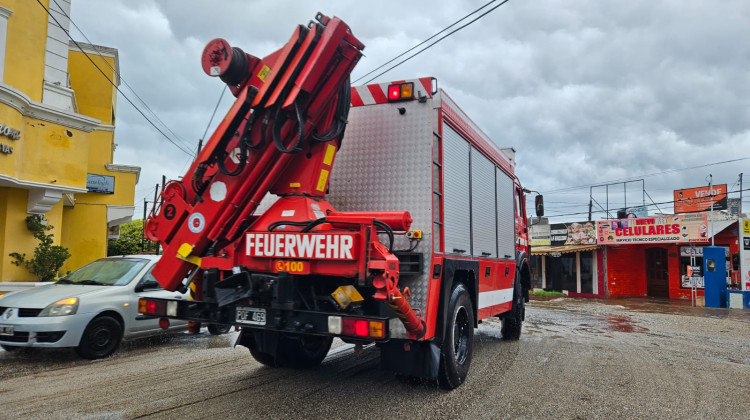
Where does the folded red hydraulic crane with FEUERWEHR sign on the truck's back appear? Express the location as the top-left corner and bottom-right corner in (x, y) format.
(145, 14), (424, 338)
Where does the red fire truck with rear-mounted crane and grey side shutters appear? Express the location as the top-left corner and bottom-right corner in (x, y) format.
(139, 14), (543, 389)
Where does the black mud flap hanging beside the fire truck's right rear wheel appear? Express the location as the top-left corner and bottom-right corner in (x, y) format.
(380, 340), (440, 379)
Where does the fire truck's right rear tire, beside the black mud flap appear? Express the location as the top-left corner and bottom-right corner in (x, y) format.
(438, 283), (474, 389)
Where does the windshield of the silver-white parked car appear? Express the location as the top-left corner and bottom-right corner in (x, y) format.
(64, 259), (148, 286)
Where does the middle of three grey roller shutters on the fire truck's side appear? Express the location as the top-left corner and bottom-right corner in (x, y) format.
(471, 148), (497, 257)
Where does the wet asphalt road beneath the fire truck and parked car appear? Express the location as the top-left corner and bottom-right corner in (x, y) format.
(0, 299), (750, 419)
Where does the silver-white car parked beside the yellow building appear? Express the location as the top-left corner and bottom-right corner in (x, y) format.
(0, 255), (228, 359)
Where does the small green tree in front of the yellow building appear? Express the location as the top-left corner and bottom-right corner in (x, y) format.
(8, 215), (70, 281)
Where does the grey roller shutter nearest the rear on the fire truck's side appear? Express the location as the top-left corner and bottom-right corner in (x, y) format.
(443, 124), (471, 255)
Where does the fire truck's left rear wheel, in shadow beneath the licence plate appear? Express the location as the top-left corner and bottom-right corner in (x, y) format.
(242, 333), (333, 369)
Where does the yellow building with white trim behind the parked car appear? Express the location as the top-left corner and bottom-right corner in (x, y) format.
(0, 0), (140, 282)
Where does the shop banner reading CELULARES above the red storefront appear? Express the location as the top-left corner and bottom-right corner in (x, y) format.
(600, 213), (709, 245)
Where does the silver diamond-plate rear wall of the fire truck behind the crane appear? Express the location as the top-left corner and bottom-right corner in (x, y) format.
(327, 100), (433, 311)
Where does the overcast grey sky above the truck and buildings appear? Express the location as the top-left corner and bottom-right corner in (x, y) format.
(71, 0), (750, 222)
